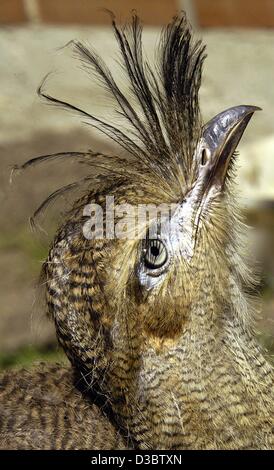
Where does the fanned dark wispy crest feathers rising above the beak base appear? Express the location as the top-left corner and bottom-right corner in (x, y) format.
(15, 14), (205, 220)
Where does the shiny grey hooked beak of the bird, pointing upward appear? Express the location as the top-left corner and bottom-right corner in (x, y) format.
(199, 105), (261, 187)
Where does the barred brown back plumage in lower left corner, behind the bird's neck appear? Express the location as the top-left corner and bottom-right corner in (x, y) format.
(0, 364), (126, 450)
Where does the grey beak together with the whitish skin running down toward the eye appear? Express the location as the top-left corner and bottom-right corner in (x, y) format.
(167, 106), (260, 260)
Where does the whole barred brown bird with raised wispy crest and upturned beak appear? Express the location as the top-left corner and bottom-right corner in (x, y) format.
(1, 13), (274, 450)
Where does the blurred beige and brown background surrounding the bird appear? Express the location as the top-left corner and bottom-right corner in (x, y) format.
(0, 0), (274, 367)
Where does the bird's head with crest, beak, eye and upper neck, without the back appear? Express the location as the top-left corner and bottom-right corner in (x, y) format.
(20, 16), (258, 446)
